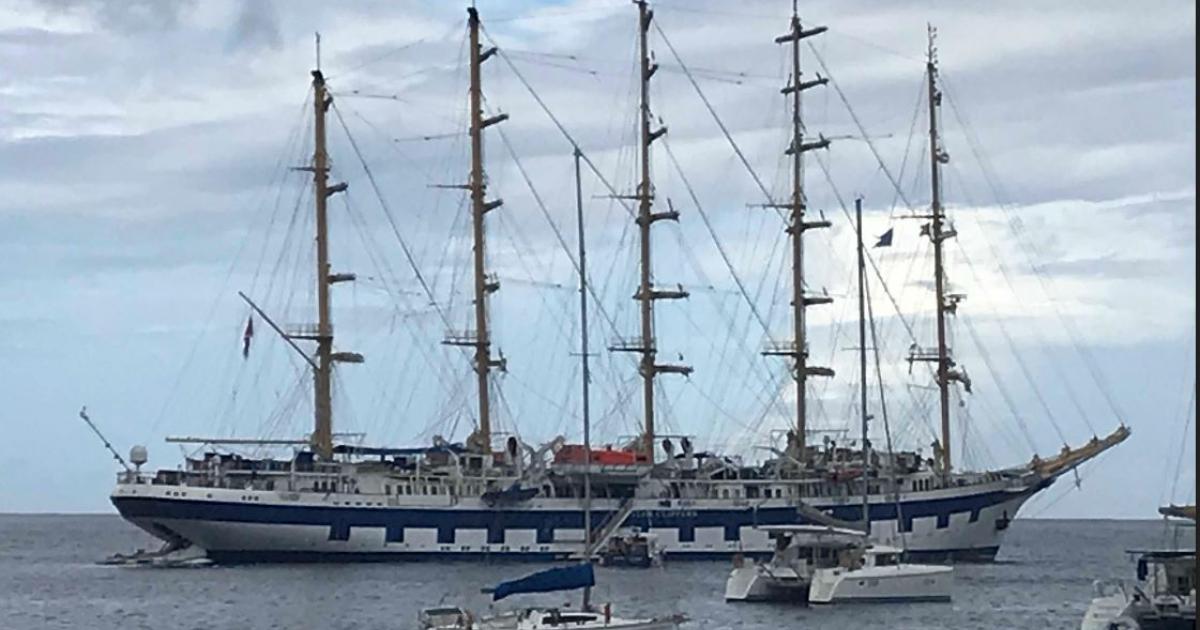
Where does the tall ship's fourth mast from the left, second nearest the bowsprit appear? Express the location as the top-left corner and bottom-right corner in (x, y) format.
(763, 1), (833, 462)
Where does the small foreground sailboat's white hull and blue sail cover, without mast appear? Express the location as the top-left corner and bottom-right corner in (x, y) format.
(418, 563), (688, 630)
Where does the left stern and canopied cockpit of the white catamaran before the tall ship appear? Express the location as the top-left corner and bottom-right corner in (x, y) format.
(725, 524), (865, 602)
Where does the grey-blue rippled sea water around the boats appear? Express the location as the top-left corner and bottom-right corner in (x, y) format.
(0, 515), (1195, 630)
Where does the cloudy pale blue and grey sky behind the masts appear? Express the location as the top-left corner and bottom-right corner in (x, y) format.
(0, 0), (1195, 517)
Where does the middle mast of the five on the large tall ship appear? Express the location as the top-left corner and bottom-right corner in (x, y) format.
(612, 0), (692, 463)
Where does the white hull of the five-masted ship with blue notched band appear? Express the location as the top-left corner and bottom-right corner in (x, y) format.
(112, 481), (1044, 563)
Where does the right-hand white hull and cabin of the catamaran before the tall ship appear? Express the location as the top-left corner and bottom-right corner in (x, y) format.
(809, 545), (954, 604)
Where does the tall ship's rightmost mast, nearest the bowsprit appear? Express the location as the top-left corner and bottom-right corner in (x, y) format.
(910, 26), (971, 475)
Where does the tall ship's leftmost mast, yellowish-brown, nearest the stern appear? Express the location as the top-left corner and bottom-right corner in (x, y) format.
(307, 60), (352, 461)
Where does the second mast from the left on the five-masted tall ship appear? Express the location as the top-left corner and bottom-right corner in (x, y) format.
(445, 7), (509, 452)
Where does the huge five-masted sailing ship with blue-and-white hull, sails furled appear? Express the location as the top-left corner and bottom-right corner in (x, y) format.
(112, 0), (1129, 563)
